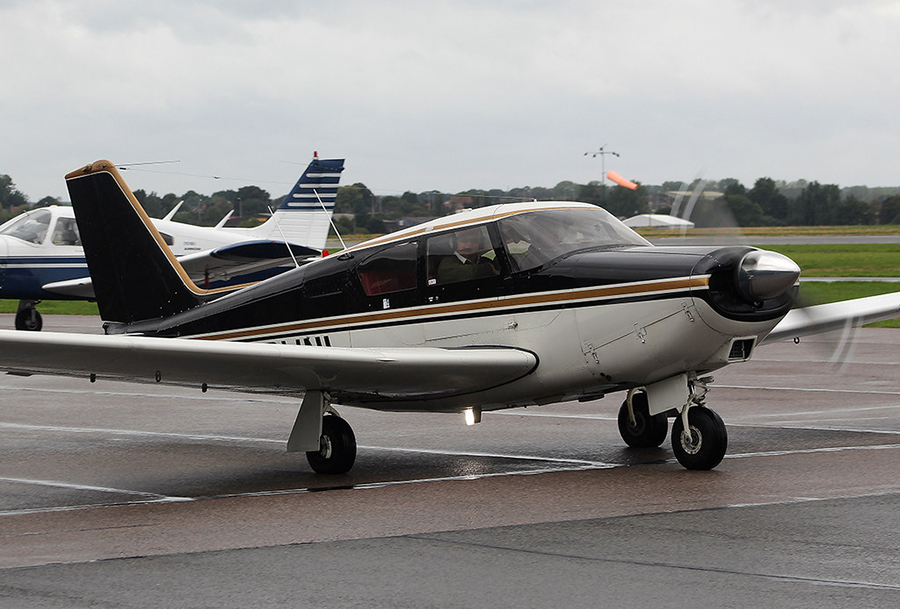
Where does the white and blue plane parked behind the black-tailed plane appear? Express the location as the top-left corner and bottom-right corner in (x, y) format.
(0, 155), (344, 330)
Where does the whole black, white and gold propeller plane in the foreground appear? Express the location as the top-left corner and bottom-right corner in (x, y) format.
(0, 161), (900, 473)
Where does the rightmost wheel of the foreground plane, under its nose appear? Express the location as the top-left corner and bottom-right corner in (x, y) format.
(672, 406), (728, 470)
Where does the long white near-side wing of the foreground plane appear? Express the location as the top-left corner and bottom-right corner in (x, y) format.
(0, 330), (537, 405)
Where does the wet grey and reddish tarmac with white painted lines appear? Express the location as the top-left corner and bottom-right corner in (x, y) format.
(0, 316), (900, 609)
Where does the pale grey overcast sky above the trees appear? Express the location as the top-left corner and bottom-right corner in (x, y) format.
(0, 0), (900, 201)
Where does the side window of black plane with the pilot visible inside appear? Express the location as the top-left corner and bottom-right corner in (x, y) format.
(426, 226), (500, 286)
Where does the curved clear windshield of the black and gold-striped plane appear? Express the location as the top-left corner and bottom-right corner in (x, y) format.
(498, 207), (650, 272)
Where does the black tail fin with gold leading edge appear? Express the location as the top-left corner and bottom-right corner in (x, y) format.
(66, 161), (205, 324)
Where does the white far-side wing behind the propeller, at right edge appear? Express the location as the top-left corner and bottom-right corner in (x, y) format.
(760, 292), (900, 344)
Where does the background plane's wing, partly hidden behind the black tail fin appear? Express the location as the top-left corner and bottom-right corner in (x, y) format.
(41, 241), (321, 300)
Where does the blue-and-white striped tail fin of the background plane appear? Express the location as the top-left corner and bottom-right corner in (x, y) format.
(252, 153), (344, 250)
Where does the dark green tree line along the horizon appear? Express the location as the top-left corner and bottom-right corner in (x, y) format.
(0, 174), (900, 234)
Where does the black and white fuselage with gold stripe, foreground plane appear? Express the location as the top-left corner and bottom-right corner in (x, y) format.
(108, 204), (791, 411)
